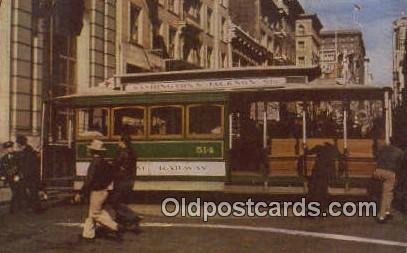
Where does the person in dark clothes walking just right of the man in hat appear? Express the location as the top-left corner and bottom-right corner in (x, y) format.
(111, 135), (140, 232)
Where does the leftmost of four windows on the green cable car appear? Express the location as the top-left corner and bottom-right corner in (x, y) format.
(78, 108), (109, 138)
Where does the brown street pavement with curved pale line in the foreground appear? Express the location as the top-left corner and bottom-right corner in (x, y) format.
(0, 200), (407, 253)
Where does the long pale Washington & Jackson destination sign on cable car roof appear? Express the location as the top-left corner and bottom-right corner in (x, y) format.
(125, 77), (287, 92)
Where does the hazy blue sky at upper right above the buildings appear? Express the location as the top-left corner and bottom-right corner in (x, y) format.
(299, 0), (407, 85)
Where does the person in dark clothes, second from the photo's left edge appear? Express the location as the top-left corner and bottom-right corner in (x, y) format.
(16, 135), (44, 213)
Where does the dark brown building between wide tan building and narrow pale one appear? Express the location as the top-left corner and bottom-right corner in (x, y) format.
(230, 0), (304, 66)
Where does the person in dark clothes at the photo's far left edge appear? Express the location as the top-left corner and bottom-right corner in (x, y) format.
(0, 141), (25, 214)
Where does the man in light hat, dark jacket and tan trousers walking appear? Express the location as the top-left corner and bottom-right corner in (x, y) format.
(75, 140), (122, 241)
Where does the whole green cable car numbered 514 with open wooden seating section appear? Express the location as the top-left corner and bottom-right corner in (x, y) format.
(53, 66), (391, 191)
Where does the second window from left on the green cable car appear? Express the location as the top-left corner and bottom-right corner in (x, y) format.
(113, 107), (145, 137)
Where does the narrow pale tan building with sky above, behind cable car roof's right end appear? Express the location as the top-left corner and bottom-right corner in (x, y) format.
(295, 14), (322, 66)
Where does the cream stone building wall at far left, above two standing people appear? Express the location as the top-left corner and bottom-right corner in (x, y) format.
(0, 1), (43, 144)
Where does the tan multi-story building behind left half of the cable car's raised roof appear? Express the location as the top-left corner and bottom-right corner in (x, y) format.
(117, 0), (233, 73)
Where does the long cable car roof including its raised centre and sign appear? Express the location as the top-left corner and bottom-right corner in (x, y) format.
(54, 66), (391, 103)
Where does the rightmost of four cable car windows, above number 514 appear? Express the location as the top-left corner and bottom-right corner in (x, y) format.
(187, 105), (223, 136)
